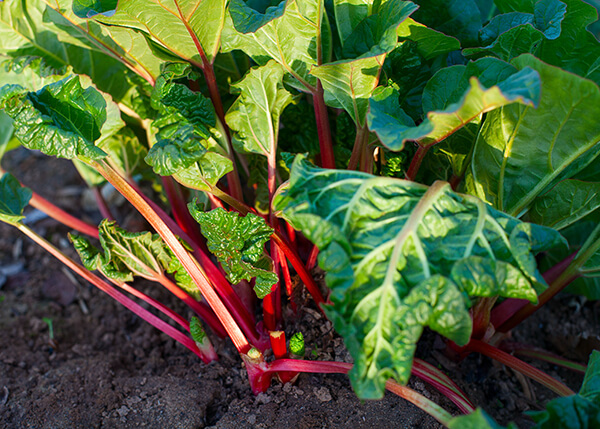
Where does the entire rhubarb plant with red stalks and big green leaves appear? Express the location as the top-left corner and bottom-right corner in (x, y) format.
(0, 0), (600, 428)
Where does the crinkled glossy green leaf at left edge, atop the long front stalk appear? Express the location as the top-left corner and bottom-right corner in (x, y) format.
(0, 76), (124, 159)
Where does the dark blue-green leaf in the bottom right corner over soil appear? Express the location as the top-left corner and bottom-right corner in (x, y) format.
(527, 350), (600, 429)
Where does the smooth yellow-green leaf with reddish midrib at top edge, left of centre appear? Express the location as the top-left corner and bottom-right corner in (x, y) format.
(74, 0), (227, 66)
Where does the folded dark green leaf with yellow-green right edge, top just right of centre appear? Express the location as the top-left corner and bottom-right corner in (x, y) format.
(343, 0), (417, 58)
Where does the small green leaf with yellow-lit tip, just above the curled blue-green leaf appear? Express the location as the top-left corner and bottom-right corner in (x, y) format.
(397, 18), (460, 60)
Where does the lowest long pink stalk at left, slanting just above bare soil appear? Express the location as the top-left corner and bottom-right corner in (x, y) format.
(17, 225), (216, 363)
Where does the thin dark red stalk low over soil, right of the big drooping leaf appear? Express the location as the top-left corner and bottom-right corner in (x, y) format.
(465, 340), (575, 396)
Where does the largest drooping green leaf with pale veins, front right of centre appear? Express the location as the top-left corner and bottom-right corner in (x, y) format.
(274, 156), (562, 398)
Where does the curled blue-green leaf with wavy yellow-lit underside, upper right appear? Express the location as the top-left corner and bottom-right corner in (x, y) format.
(367, 58), (540, 151)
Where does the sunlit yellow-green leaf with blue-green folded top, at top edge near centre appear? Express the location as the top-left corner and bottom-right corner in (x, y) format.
(222, 0), (329, 90)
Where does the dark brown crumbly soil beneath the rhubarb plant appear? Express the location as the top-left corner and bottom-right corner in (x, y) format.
(0, 150), (600, 429)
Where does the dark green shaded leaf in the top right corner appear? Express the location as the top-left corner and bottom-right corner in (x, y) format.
(536, 0), (600, 85)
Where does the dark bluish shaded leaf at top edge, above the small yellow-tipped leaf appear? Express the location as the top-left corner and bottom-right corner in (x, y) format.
(413, 0), (481, 46)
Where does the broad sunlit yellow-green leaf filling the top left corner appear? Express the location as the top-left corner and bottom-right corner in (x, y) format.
(0, 0), (137, 100)
